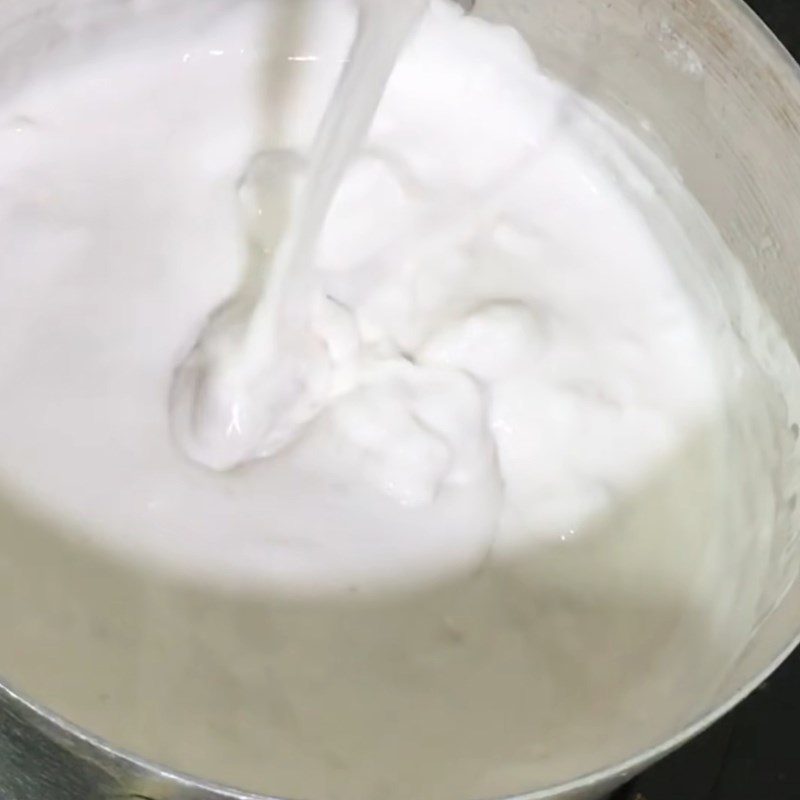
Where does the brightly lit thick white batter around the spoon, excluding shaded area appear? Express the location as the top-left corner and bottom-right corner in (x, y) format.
(0, 2), (720, 591)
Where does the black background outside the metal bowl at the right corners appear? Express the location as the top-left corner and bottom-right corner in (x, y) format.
(614, 0), (800, 800)
